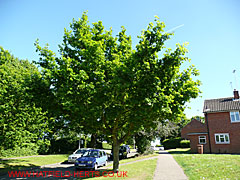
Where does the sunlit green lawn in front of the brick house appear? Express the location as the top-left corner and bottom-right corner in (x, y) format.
(168, 149), (240, 180)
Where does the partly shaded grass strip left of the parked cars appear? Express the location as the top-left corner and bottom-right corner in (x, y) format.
(0, 154), (69, 172)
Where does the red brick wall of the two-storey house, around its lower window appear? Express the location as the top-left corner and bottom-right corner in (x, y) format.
(205, 112), (240, 153)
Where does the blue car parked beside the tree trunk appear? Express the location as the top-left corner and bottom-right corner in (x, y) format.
(75, 149), (108, 170)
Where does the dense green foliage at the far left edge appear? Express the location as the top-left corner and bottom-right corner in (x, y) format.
(0, 48), (48, 154)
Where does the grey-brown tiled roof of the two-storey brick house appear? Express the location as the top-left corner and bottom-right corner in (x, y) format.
(203, 97), (240, 112)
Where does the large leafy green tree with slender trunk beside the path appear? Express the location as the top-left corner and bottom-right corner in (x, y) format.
(36, 13), (200, 171)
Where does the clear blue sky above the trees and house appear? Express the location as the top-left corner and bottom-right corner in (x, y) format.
(0, 0), (240, 117)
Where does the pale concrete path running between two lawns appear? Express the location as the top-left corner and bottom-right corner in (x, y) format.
(153, 151), (188, 180)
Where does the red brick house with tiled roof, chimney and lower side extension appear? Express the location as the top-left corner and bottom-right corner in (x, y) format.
(181, 90), (240, 153)
